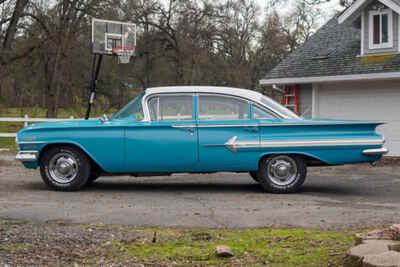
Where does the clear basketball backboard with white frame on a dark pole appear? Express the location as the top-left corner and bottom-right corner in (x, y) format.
(92, 18), (136, 56)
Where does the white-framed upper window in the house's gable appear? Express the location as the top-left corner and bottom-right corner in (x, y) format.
(369, 9), (393, 49)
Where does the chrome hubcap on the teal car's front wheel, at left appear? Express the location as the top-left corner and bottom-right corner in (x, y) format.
(49, 152), (78, 184)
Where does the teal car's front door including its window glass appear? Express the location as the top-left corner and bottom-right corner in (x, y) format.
(126, 94), (198, 172)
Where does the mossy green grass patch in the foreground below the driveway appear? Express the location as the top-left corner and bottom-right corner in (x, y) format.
(105, 229), (354, 266)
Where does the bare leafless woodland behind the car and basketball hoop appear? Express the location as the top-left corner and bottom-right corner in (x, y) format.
(0, 0), (332, 114)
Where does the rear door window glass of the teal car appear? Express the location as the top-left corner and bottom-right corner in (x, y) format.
(199, 95), (249, 121)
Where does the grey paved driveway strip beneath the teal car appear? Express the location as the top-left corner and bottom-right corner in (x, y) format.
(0, 161), (400, 229)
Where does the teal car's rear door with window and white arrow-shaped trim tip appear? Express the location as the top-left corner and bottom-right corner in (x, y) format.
(198, 94), (260, 171)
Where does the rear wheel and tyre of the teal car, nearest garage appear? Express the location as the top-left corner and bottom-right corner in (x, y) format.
(258, 155), (307, 193)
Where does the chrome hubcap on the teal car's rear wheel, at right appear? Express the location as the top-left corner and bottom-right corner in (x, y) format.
(267, 155), (297, 186)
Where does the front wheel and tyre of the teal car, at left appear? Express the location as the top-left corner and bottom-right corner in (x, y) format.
(40, 146), (90, 191)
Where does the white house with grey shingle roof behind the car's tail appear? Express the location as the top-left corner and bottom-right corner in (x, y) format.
(260, 0), (400, 156)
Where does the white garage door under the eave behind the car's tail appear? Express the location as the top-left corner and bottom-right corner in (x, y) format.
(314, 81), (400, 156)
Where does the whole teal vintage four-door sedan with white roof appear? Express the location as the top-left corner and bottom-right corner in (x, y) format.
(16, 86), (388, 193)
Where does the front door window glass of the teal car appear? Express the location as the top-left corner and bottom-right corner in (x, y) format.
(148, 95), (193, 121)
